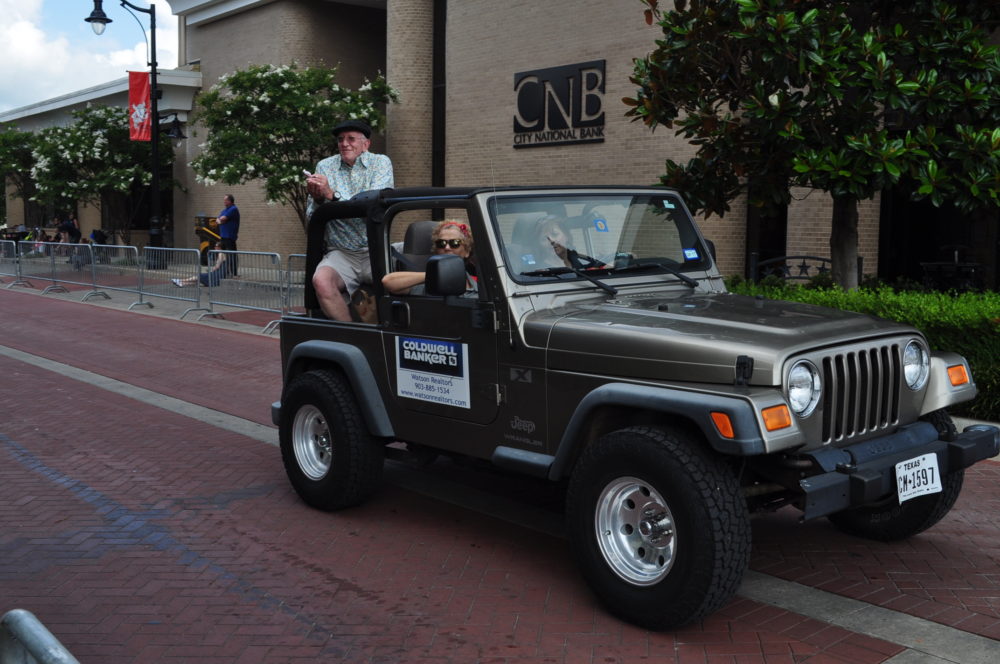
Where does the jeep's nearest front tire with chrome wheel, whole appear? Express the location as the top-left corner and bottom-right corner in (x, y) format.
(566, 427), (751, 630)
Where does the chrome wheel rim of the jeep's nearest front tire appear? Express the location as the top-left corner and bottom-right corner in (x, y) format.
(594, 477), (677, 586)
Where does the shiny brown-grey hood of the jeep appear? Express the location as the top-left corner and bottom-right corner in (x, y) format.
(524, 293), (916, 385)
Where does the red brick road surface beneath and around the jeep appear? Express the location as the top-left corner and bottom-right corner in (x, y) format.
(0, 290), (1000, 664)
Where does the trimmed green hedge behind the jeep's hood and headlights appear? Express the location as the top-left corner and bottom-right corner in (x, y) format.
(727, 278), (1000, 422)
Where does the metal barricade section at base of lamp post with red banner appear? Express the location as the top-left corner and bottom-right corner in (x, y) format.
(129, 247), (210, 318)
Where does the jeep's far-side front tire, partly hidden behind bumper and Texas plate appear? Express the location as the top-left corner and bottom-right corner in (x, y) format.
(827, 410), (965, 542)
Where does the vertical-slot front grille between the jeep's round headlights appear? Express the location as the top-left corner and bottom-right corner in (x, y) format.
(822, 344), (901, 444)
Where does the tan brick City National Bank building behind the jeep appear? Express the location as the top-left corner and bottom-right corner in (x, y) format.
(0, 0), (1000, 286)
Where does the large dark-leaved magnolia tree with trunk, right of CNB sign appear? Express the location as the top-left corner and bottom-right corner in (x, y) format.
(624, 0), (1000, 287)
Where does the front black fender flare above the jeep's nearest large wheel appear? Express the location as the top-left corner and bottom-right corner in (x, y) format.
(548, 383), (767, 480)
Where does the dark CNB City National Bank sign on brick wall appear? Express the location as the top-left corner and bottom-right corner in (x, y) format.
(514, 60), (604, 148)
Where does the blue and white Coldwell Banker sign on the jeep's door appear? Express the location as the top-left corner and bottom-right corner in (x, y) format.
(396, 337), (471, 408)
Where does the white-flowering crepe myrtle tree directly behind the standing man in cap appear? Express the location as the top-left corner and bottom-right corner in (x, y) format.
(191, 63), (397, 228)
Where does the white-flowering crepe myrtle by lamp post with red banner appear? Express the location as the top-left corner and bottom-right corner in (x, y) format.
(31, 106), (174, 242)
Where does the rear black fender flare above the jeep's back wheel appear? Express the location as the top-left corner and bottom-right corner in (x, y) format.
(280, 340), (395, 438)
